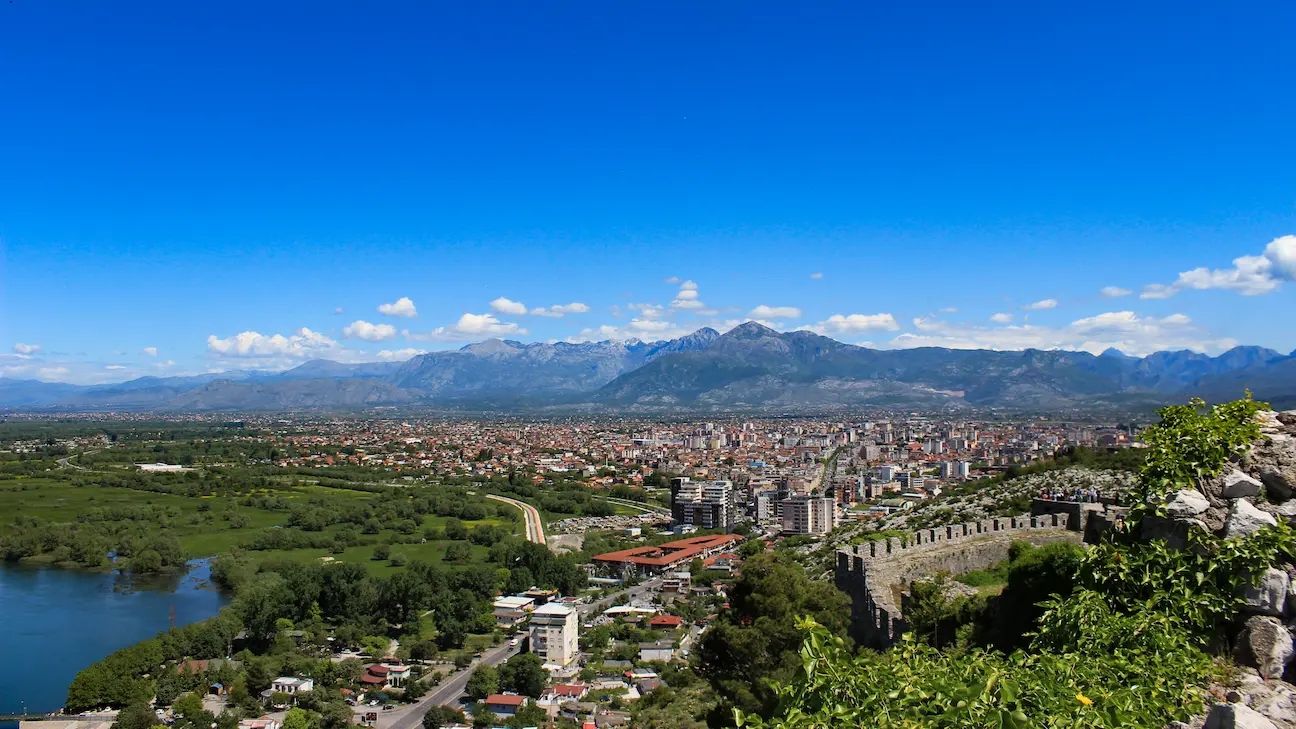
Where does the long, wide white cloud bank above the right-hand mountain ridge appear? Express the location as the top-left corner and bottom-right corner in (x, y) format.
(889, 311), (1238, 355)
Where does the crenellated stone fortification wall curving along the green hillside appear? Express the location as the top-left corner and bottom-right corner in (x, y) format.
(835, 514), (1078, 649)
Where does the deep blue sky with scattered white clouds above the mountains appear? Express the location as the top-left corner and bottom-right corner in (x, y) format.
(0, 0), (1296, 383)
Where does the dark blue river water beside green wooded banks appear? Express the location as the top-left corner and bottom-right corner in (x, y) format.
(0, 560), (227, 729)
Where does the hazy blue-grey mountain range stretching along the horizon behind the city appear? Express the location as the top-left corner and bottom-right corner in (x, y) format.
(0, 322), (1296, 412)
